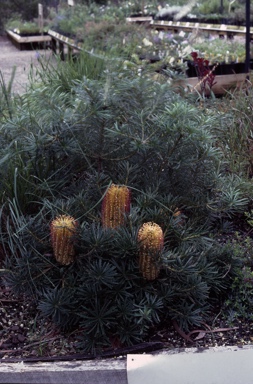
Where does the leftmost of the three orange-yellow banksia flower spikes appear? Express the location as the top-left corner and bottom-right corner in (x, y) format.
(51, 215), (77, 265)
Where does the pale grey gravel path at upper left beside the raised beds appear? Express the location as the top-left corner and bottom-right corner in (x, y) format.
(0, 36), (51, 94)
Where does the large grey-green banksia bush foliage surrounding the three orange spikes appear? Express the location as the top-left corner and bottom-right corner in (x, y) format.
(0, 49), (249, 353)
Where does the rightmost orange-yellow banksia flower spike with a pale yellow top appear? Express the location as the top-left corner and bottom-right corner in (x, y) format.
(138, 222), (164, 280)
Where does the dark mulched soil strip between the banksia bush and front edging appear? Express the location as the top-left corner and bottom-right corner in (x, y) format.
(0, 281), (253, 364)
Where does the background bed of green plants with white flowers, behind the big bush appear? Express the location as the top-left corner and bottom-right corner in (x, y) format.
(47, 3), (245, 68)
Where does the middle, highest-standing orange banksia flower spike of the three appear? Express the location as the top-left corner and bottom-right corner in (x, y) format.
(102, 184), (130, 228)
